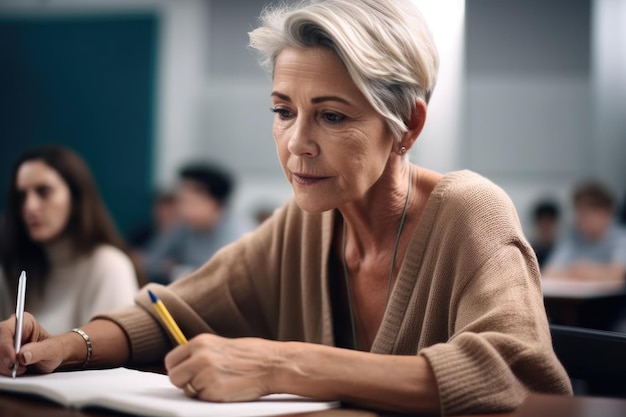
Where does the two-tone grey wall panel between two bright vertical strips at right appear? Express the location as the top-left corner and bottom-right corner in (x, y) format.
(463, 0), (595, 230)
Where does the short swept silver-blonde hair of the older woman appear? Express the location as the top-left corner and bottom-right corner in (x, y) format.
(249, 0), (439, 140)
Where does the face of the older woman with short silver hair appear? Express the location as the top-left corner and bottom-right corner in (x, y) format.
(272, 48), (393, 212)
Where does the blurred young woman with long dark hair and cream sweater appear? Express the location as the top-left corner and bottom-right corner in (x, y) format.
(0, 146), (137, 334)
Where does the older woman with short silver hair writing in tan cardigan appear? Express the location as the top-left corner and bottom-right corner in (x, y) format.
(0, 0), (570, 414)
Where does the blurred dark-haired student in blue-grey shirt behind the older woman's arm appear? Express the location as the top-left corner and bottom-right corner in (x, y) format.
(144, 164), (254, 284)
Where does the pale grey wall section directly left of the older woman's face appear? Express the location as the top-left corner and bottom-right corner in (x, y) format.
(194, 0), (291, 214)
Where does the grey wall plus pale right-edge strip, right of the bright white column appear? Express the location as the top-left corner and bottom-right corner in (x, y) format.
(463, 0), (626, 234)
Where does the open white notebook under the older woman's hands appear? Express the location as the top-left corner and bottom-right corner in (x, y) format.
(0, 368), (339, 417)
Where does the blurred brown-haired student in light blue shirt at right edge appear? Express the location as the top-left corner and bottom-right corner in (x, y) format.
(544, 182), (626, 280)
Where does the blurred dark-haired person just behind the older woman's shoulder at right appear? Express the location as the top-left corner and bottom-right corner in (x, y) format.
(531, 200), (560, 267)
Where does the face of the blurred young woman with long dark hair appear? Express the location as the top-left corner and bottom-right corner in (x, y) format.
(16, 160), (72, 243)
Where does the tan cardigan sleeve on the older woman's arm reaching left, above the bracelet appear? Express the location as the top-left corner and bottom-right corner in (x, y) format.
(96, 205), (287, 364)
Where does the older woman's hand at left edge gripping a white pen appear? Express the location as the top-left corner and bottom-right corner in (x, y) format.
(0, 313), (64, 376)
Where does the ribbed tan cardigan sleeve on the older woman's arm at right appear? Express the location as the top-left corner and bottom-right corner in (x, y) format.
(420, 240), (571, 415)
